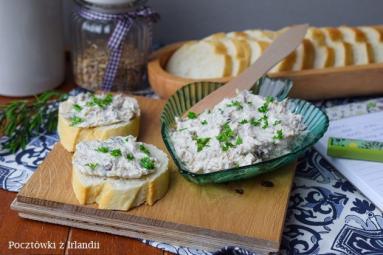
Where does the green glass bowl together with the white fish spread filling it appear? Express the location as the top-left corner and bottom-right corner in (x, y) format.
(161, 77), (328, 184)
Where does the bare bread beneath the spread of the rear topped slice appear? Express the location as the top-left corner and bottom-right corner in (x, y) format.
(57, 99), (140, 152)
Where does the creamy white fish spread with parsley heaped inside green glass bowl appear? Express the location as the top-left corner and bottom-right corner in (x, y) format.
(171, 91), (305, 173)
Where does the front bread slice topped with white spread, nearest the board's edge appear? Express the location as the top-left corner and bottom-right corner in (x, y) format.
(72, 136), (169, 210)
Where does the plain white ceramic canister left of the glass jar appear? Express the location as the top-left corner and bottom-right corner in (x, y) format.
(0, 0), (65, 96)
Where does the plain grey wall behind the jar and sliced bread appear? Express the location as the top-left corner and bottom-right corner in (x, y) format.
(63, 0), (383, 43)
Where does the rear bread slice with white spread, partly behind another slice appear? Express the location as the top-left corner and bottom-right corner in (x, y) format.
(57, 93), (140, 152)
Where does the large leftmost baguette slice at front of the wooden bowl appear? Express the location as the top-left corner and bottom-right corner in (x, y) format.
(166, 40), (232, 79)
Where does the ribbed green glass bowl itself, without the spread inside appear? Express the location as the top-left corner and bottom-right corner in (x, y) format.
(161, 77), (329, 184)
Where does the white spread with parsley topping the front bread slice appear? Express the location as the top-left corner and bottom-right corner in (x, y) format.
(73, 136), (160, 179)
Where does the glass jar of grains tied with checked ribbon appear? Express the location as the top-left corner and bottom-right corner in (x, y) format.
(72, 0), (159, 92)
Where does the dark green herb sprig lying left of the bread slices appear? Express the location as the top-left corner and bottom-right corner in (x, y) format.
(0, 91), (66, 153)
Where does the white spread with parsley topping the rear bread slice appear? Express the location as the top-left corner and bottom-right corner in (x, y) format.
(59, 93), (140, 128)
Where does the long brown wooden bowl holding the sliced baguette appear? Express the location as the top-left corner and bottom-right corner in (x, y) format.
(148, 42), (383, 100)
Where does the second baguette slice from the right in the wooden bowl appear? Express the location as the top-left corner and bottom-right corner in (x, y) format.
(338, 26), (374, 65)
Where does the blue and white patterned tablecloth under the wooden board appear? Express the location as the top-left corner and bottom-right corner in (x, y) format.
(0, 92), (383, 255)
